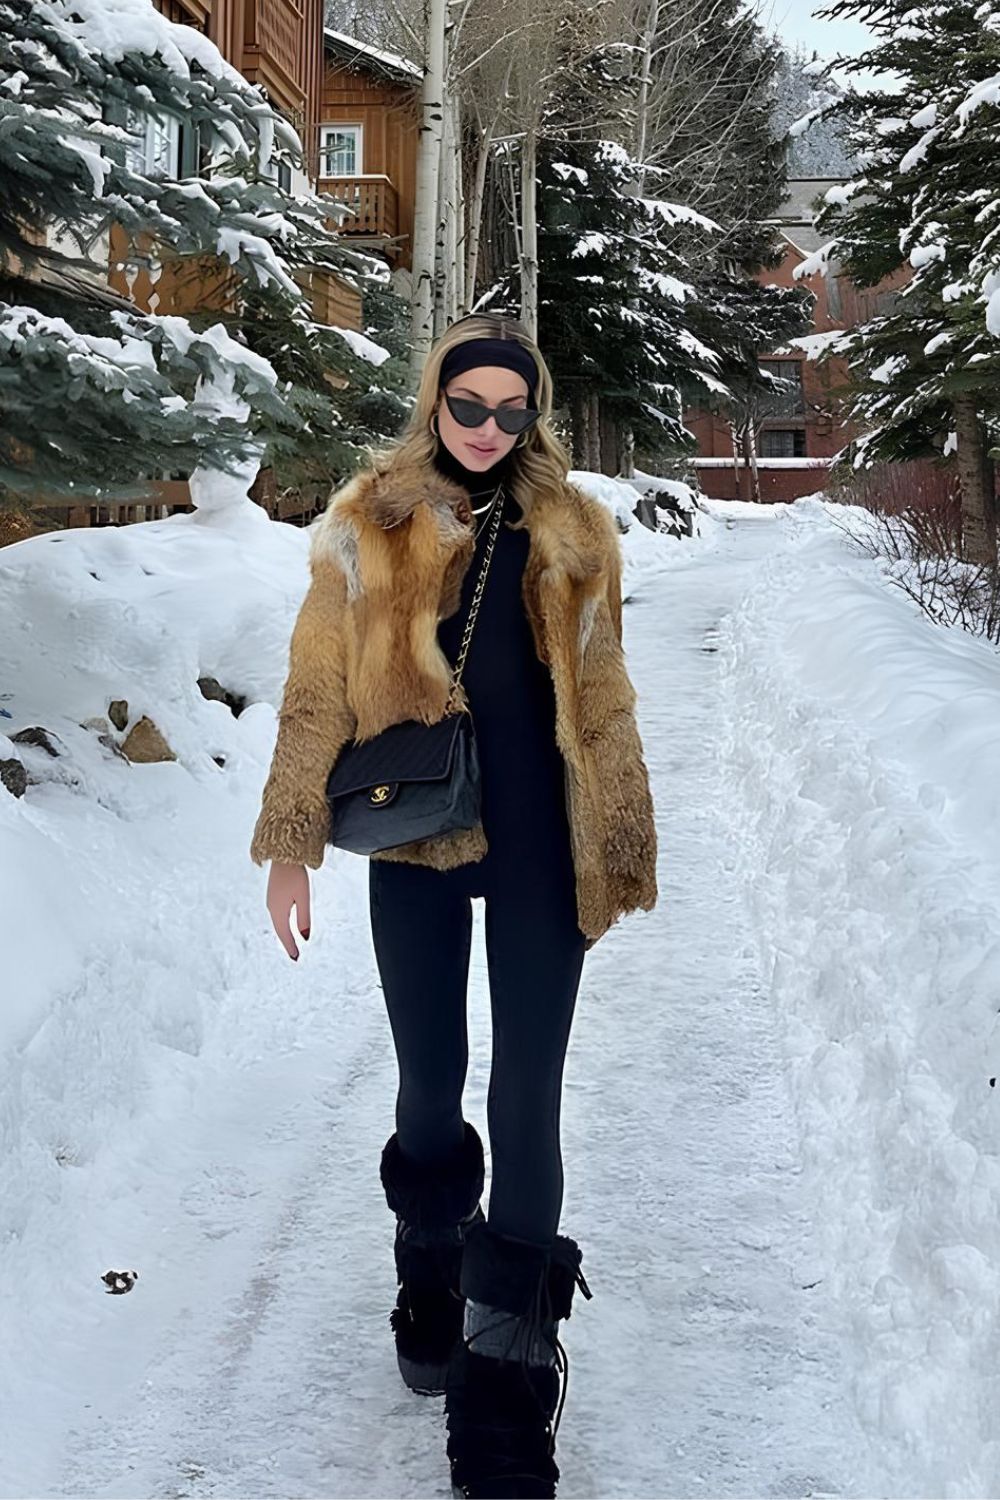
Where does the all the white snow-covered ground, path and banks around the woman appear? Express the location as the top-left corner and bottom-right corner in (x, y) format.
(0, 476), (1000, 1500)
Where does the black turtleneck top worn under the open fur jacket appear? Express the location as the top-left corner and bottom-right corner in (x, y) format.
(435, 443), (568, 858)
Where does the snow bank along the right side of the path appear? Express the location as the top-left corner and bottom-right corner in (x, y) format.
(720, 500), (1000, 1496)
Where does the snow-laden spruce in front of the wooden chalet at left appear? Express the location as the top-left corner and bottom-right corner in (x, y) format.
(0, 0), (381, 513)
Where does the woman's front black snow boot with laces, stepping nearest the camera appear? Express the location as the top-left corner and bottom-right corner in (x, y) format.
(444, 1223), (592, 1500)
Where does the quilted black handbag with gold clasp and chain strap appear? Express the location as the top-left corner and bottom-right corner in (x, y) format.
(327, 491), (504, 855)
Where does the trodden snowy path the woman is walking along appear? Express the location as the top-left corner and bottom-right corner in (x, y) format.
(7, 518), (982, 1500)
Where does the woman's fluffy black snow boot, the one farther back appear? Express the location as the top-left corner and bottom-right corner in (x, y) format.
(379, 1121), (484, 1395)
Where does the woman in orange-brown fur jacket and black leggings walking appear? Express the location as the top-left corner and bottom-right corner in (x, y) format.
(250, 315), (657, 1496)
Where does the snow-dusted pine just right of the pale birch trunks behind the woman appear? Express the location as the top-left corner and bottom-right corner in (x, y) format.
(521, 48), (717, 474)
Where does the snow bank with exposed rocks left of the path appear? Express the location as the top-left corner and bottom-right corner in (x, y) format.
(0, 489), (364, 1494)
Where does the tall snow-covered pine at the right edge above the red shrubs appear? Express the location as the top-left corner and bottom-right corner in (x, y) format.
(805, 0), (1000, 563)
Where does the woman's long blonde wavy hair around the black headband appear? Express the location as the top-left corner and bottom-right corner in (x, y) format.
(370, 312), (570, 530)
